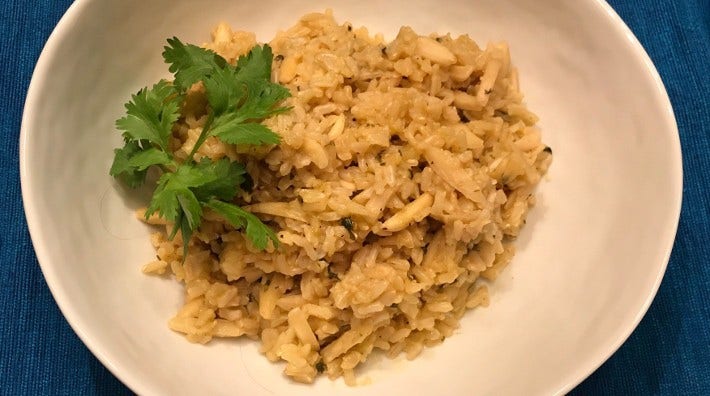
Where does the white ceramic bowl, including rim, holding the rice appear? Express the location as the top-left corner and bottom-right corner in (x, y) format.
(20, 0), (682, 395)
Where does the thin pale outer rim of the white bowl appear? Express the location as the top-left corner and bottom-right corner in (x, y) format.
(19, 0), (683, 395)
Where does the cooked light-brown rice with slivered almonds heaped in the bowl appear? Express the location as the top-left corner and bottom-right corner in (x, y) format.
(143, 12), (552, 384)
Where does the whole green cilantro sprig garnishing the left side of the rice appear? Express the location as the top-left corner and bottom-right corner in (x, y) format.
(109, 37), (290, 257)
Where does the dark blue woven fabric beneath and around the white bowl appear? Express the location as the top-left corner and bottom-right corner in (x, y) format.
(0, 0), (710, 395)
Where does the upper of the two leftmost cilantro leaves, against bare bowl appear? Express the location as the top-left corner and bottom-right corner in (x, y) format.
(116, 80), (181, 151)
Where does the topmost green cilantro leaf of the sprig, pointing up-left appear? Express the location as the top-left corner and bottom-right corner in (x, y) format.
(163, 37), (227, 91)
